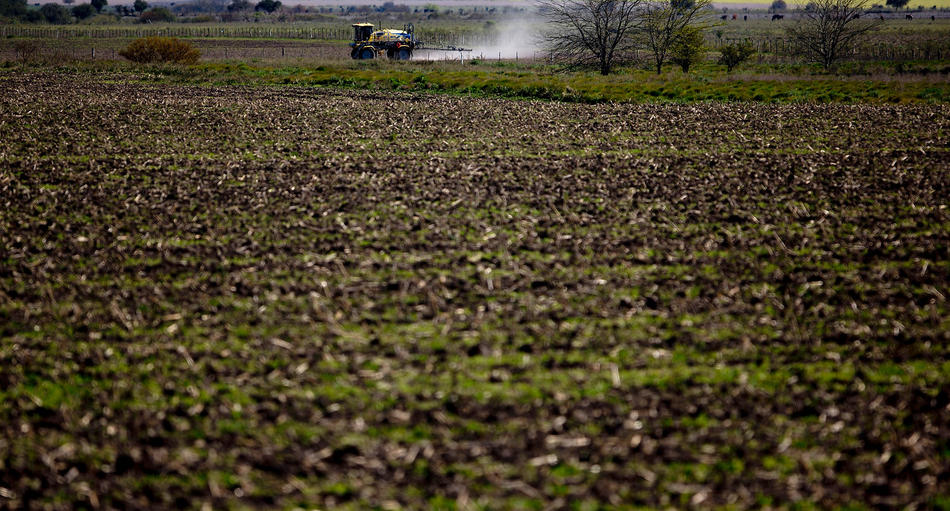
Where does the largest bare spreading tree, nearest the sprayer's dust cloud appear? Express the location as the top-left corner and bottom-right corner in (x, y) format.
(540, 0), (642, 75)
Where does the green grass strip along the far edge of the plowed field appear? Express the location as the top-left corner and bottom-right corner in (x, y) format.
(98, 60), (950, 103)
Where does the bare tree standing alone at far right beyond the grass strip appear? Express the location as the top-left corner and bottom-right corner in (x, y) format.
(788, 0), (880, 69)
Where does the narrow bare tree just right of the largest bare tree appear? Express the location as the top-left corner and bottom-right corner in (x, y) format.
(642, 0), (711, 74)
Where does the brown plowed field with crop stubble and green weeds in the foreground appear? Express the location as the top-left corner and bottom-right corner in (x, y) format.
(0, 72), (950, 509)
